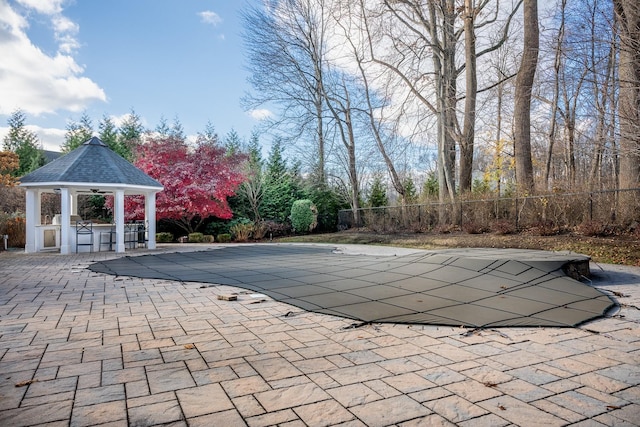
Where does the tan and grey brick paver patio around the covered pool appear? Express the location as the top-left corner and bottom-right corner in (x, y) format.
(0, 246), (640, 426)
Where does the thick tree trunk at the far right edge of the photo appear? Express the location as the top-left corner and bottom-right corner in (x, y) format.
(613, 0), (640, 188)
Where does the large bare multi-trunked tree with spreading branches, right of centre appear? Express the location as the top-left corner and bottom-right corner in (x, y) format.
(361, 0), (520, 201)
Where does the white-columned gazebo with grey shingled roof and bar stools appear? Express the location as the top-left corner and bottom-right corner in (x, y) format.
(20, 137), (164, 254)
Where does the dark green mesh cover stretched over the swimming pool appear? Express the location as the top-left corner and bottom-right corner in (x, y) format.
(89, 244), (615, 328)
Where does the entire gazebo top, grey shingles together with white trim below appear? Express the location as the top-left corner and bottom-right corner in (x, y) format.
(20, 137), (163, 194)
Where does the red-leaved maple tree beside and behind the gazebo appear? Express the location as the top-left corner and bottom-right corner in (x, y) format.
(116, 137), (245, 233)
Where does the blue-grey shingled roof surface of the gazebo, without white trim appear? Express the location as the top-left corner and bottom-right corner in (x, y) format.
(20, 137), (162, 188)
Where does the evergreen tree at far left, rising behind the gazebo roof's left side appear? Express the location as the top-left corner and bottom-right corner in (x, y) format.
(3, 110), (46, 177)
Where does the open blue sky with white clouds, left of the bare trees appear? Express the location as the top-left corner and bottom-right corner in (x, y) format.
(0, 0), (268, 151)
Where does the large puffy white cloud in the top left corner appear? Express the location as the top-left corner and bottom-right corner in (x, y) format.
(0, 0), (107, 115)
